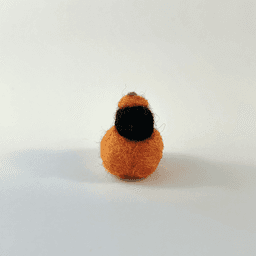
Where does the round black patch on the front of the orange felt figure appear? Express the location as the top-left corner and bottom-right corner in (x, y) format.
(115, 106), (154, 141)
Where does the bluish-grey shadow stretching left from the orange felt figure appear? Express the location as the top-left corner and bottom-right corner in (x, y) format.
(4, 149), (110, 183)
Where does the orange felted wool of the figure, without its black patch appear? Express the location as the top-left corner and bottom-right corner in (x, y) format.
(100, 93), (164, 179)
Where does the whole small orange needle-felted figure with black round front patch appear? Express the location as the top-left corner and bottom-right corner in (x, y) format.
(100, 92), (164, 180)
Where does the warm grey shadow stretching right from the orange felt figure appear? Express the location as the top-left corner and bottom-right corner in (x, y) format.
(140, 153), (256, 190)
